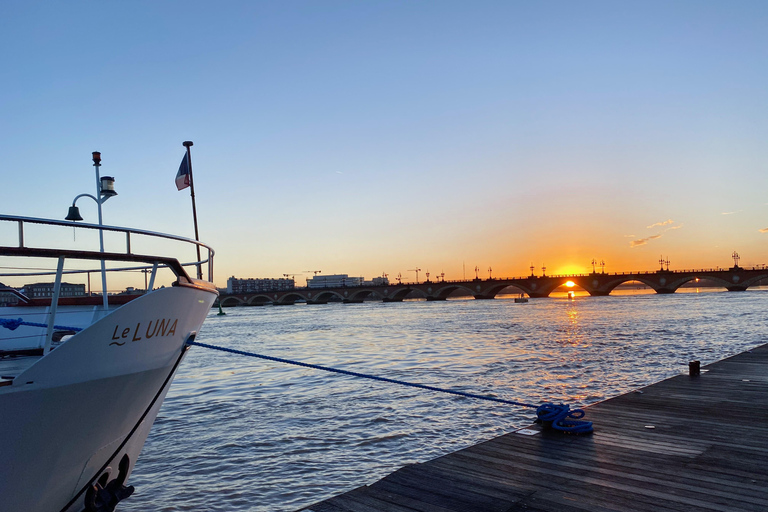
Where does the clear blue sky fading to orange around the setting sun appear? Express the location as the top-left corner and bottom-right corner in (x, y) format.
(0, 0), (768, 286)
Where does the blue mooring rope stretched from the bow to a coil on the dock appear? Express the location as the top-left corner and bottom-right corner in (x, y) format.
(187, 340), (593, 434)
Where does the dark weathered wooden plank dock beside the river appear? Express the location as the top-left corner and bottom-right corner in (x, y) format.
(302, 345), (768, 512)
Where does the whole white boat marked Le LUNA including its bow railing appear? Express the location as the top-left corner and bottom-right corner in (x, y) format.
(0, 157), (217, 512)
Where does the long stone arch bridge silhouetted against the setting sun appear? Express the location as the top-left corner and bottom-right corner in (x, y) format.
(219, 267), (768, 307)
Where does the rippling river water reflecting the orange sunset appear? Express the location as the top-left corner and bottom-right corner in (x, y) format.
(119, 288), (768, 512)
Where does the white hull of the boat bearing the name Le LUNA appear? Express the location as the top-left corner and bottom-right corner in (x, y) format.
(0, 286), (216, 512)
